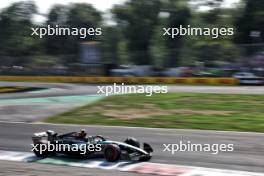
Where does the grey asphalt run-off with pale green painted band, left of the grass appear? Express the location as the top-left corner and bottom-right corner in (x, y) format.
(0, 82), (102, 122)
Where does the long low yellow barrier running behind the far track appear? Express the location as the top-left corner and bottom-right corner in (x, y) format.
(0, 76), (238, 85)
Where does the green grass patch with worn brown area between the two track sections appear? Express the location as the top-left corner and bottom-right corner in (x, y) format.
(46, 93), (264, 132)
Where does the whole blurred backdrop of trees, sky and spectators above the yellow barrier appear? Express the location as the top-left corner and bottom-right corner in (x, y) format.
(0, 0), (264, 77)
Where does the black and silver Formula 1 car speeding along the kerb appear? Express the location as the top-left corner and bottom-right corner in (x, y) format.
(32, 130), (153, 162)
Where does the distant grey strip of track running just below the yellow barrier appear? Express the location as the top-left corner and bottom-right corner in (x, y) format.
(0, 82), (264, 101)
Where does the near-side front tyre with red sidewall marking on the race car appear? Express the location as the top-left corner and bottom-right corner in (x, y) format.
(104, 144), (121, 162)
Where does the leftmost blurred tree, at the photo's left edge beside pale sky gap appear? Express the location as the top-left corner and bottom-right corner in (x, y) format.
(0, 1), (39, 65)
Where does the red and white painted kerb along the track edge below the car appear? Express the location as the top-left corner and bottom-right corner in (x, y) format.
(0, 150), (264, 176)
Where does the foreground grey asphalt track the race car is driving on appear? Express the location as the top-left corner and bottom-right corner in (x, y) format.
(0, 123), (264, 172)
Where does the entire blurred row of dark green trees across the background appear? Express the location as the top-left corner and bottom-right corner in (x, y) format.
(0, 0), (264, 67)
